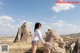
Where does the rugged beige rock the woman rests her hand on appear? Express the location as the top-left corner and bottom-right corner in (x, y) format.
(43, 29), (65, 53)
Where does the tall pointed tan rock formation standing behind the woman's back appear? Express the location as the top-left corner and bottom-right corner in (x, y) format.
(14, 22), (32, 42)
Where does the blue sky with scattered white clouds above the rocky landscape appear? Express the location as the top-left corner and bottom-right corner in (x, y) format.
(0, 0), (80, 35)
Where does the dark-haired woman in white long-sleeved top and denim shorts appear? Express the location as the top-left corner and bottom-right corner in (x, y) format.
(32, 22), (47, 53)
